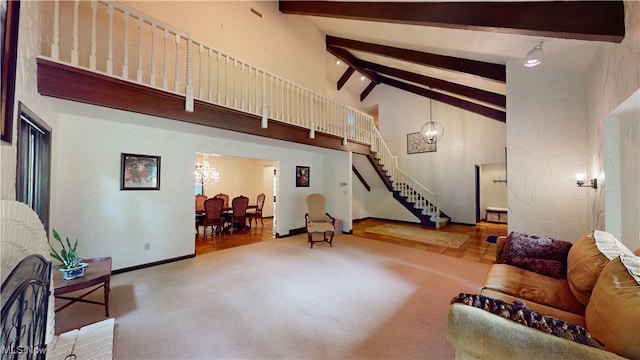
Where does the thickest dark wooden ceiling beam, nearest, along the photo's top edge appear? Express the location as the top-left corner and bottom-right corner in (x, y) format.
(280, 0), (625, 43)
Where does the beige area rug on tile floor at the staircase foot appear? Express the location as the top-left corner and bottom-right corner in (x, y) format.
(365, 224), (469, 248)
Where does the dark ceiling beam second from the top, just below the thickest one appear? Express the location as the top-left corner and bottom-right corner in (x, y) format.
(326, 35), (507, 82)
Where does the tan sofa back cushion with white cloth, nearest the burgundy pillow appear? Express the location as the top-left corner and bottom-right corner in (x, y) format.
(567, 230), (631, 305)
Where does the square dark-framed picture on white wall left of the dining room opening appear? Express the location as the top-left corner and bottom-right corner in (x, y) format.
(120, 153), (160, 190)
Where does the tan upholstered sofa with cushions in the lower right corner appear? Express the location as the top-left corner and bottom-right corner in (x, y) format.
(446, 230), (640, 359)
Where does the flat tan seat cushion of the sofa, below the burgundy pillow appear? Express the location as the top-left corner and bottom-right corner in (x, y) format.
(483, 264), (584, 315)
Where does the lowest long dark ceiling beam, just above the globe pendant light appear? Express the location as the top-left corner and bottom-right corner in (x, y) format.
(380, 76), (507, 123)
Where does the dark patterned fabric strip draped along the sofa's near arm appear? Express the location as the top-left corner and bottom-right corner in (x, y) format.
(451, 293), (604, 349)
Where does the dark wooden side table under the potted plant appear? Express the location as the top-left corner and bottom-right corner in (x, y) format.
(53, 257), (111, 317)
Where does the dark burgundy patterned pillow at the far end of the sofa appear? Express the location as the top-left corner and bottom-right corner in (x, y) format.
(497, 231), (572, 279)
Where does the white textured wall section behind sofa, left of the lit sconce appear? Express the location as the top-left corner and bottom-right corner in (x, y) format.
(507, 65), (593, 241)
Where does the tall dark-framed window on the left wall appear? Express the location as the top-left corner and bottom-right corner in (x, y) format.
(16, 104), (51, 234)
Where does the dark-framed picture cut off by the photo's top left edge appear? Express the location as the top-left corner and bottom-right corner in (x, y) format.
(0, 0), (20, 143)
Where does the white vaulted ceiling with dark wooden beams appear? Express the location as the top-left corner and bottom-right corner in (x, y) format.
(279, 0), (624, 122)
